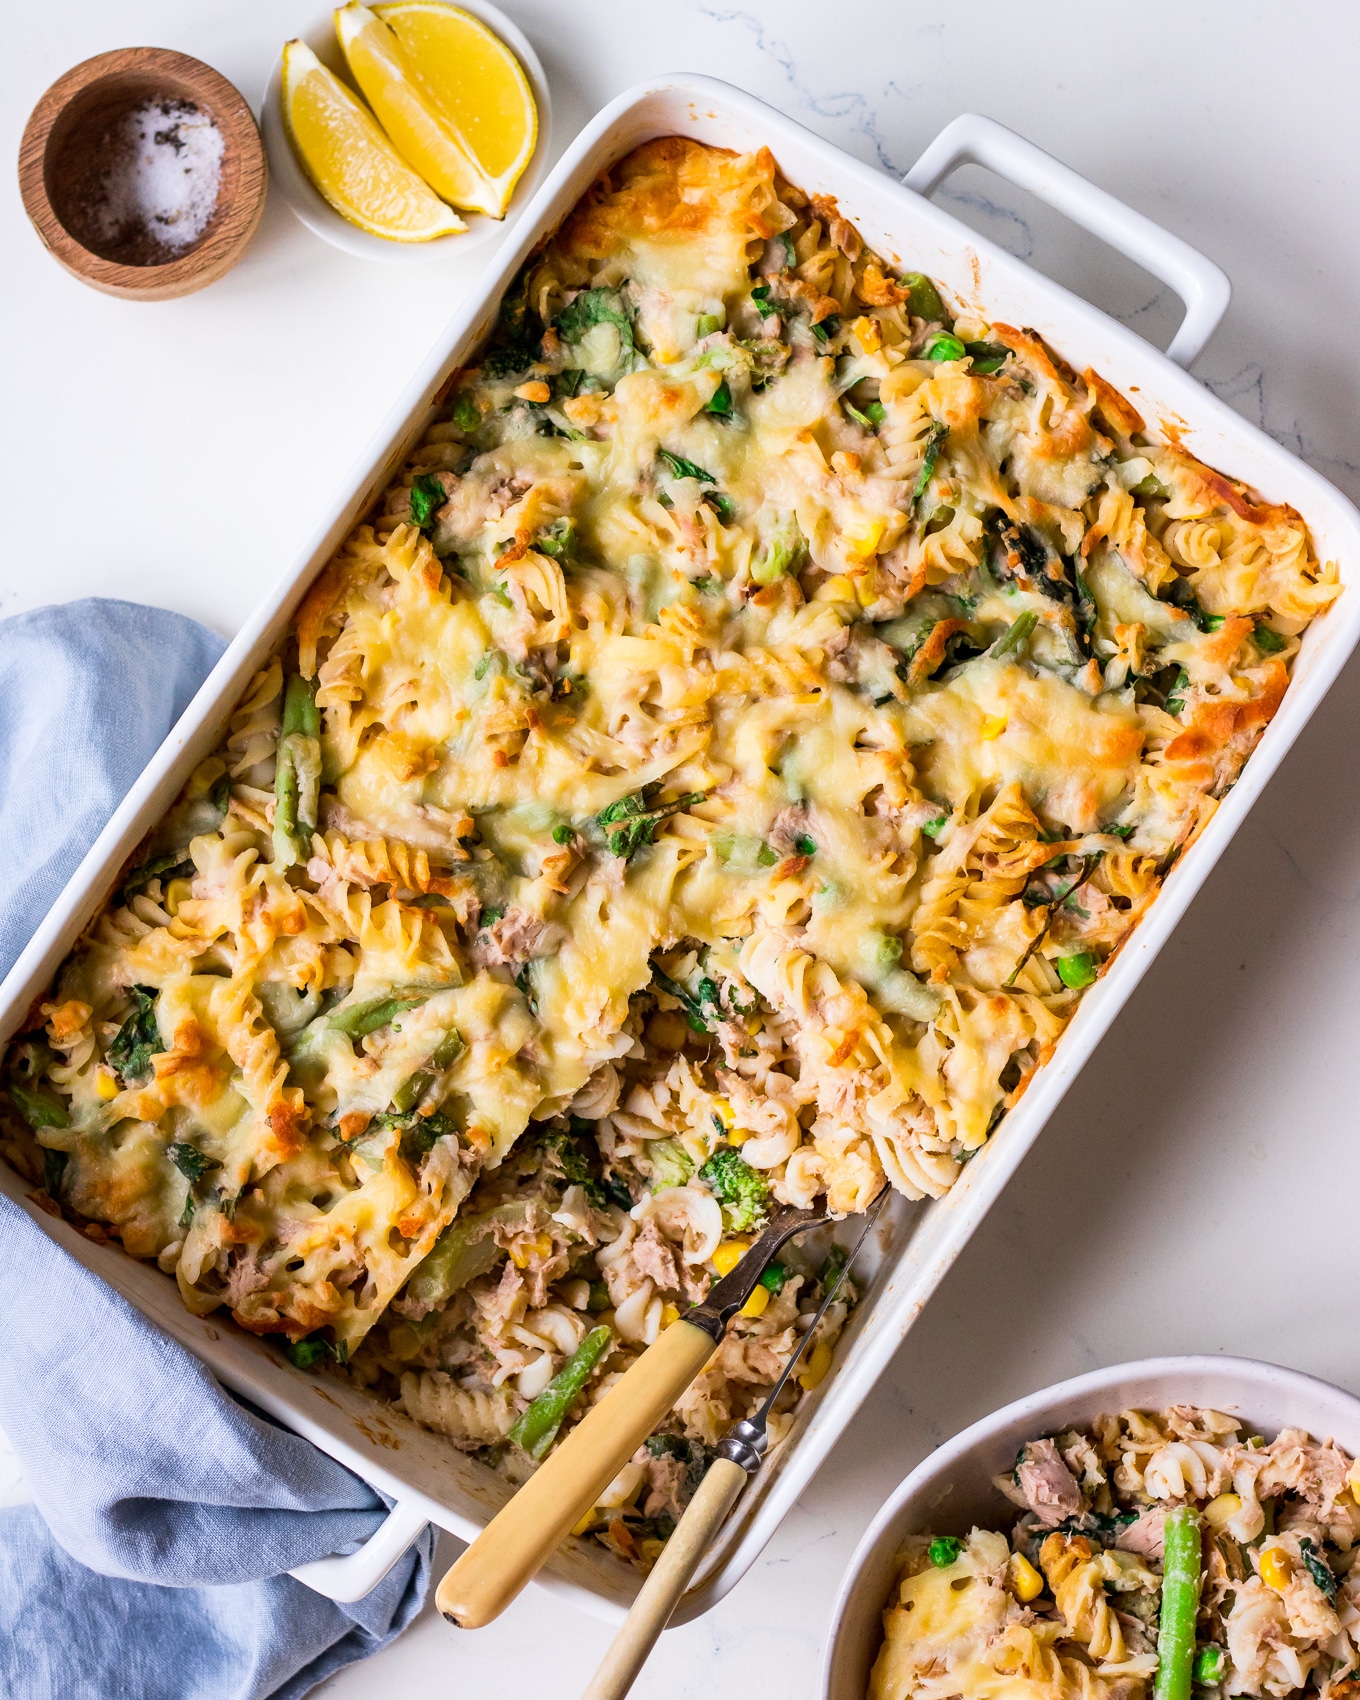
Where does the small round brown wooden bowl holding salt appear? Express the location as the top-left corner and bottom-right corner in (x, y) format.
(19, 48), (267, 301)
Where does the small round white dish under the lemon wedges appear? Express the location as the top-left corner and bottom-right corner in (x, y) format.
(260, 0), (553, 265)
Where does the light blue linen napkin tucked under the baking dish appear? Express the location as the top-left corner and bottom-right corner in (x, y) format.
(0, 600), (434, 1700)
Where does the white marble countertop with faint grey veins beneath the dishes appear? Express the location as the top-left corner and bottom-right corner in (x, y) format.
(0, 0), (1360, 1700)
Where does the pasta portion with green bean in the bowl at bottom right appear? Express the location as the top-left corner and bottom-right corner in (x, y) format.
(869, 1404), (1360, 1700)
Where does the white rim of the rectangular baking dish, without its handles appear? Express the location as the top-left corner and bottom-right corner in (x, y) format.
(0, 73), (1360, 1624)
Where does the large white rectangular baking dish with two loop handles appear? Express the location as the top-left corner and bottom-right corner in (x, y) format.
(0, 75), (1360, 1622)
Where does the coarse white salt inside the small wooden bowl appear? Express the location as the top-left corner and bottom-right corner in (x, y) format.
(92, 100), (223, 250)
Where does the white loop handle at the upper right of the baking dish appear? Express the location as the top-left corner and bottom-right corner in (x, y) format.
(903, 112), (1233, 366)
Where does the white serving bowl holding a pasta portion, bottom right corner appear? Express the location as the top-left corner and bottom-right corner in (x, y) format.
(819, 1357), (1360, 1700)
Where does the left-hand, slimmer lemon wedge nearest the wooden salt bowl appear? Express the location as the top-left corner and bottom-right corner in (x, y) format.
(282, 41), (468, 241)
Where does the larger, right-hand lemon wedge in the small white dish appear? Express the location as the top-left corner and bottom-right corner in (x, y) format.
(335, 0), (539, 218)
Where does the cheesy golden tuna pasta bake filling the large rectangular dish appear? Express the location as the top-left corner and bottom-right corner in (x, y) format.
(3, 138), (1340, 1557)
